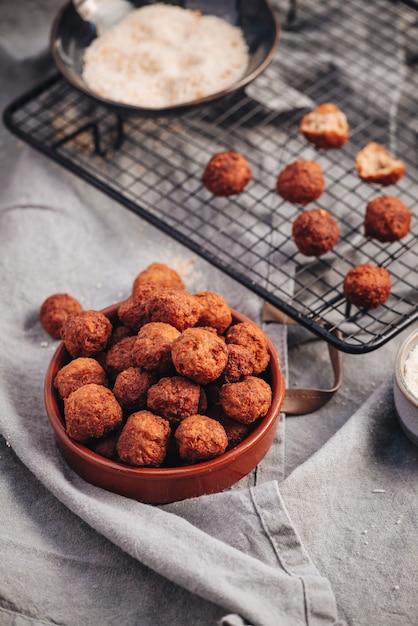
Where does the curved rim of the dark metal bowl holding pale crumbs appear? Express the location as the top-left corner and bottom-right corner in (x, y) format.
(49, 0), (281, 116)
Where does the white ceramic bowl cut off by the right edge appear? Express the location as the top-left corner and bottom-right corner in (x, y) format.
(393, 330), (418, 445)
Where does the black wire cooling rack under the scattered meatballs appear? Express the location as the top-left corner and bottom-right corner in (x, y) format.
(3, 0), (418, 354)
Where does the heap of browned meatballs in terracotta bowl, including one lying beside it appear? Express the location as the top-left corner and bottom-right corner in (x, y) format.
(40, 263), (272, 467)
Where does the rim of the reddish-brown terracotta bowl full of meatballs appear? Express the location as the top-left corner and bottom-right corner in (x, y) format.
(44, 303), (285, 481)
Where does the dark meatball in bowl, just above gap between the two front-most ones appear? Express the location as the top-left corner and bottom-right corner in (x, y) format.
(147, 376), (201, 424)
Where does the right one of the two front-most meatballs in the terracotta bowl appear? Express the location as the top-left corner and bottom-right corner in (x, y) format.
(174, 414), (228, 463)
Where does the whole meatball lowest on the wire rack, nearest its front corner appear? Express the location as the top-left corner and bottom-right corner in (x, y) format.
(343, 263), (391, 309)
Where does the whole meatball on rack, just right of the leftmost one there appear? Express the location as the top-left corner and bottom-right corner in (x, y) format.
(276, 159), (325, 205)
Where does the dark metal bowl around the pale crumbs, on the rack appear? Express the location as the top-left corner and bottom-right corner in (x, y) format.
(50, 0), (280, 116)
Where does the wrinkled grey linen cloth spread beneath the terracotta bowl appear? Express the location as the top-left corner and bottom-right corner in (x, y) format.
(0, 0), (418, 626)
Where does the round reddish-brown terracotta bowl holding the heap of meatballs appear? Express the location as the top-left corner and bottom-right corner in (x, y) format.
(44, 305), (285, 504)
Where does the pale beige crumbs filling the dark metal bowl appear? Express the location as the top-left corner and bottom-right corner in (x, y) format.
(83, 3), (249, 109)
